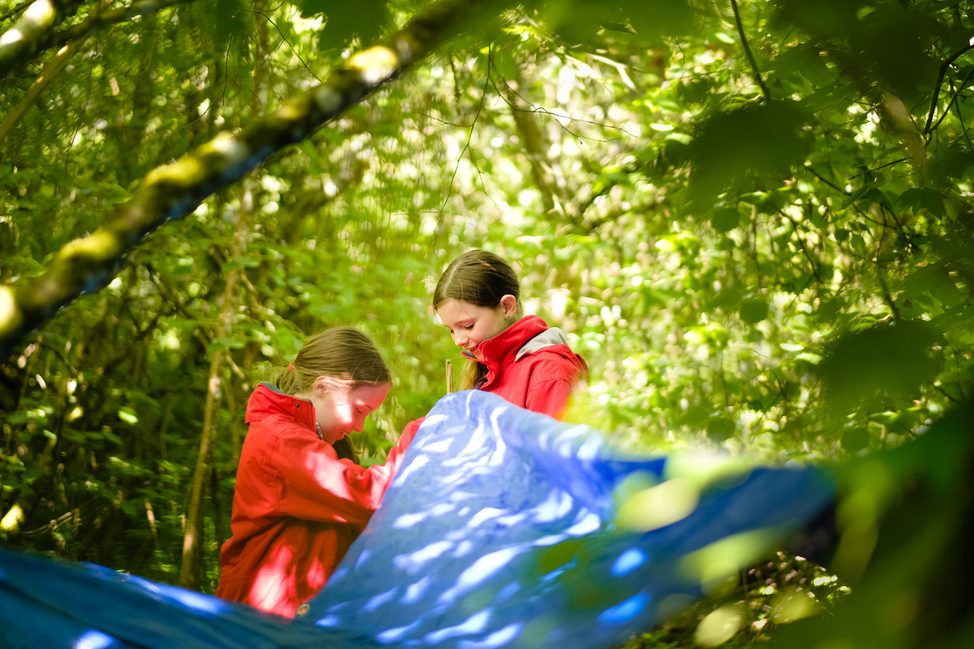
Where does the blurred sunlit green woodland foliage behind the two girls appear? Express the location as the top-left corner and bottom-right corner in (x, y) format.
(0, 0), (974, 646)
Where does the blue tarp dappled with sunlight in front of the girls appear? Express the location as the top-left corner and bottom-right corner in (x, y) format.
(0, 391), (834, 649)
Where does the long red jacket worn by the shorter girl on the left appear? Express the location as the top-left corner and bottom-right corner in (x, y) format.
(216, 384), (418, 617)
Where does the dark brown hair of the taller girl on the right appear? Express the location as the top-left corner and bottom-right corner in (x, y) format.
(433, 250), (521, 390)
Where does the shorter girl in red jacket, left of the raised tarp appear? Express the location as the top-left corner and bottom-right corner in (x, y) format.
(216, 327), (416, 617)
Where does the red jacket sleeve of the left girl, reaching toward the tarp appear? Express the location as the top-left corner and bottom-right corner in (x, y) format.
(270, 424), (418, 524)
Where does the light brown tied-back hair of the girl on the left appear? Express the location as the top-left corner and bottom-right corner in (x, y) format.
(276, 327), (392, 395)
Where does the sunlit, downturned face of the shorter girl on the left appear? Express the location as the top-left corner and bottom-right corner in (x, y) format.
(313, 376), (390, 444)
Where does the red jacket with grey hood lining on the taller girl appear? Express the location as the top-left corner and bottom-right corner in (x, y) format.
(476, 315), (588, 418)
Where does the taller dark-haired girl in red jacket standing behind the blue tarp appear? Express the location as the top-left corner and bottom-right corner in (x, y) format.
(433, 250), (587, 418)
